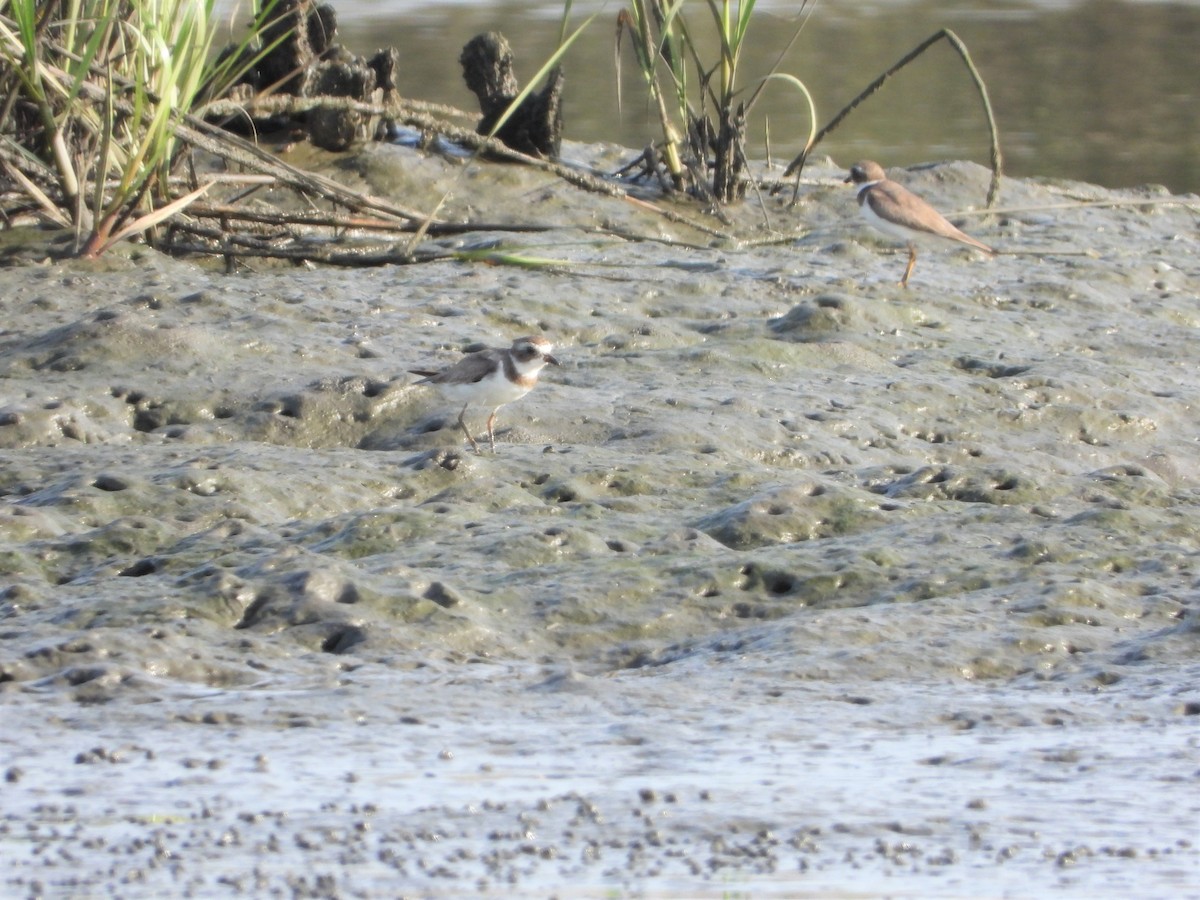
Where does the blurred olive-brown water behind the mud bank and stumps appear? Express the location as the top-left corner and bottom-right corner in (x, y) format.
(278, 0), (1200, 192)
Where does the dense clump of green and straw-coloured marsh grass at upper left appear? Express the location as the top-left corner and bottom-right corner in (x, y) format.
(0, 0), (284, 257)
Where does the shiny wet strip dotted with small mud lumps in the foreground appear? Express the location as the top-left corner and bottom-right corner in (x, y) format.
(5, 667), (1198, 898)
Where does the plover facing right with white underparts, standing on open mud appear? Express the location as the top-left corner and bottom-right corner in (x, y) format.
(409, 335), (558, 454)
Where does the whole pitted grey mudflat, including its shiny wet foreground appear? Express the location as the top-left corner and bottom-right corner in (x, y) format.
(0, 145), (1200, 898)
